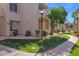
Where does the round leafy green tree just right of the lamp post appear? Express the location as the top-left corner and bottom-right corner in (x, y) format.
(48, 7), (67, 34)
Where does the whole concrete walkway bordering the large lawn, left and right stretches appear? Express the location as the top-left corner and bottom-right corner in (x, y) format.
(0, 36), (78, 56)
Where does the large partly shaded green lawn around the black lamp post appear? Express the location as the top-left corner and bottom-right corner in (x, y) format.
(0, 34), (69, 53)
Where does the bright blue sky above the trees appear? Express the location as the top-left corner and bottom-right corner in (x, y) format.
(47, 3), (79, 23)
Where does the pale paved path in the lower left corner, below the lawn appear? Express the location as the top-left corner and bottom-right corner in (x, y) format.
(0, 45), (35, 56)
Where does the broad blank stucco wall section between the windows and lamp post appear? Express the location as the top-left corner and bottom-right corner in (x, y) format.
(20, 3), (39, 35)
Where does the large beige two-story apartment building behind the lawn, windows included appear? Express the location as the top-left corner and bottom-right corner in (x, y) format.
(0, 3), (50, 36)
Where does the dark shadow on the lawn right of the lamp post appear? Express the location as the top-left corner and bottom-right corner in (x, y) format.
(35, 37), (67, 56)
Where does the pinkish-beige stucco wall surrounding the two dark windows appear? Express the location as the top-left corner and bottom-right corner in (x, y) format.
(0, 3), (47, 36)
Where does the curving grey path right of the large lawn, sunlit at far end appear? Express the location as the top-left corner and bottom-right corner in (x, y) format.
(37, 36), (78, 56)
